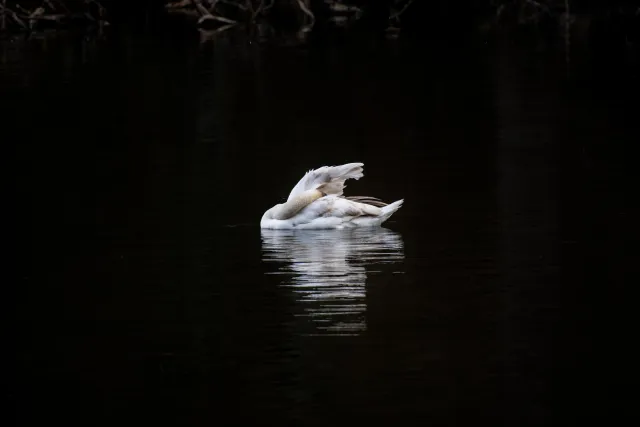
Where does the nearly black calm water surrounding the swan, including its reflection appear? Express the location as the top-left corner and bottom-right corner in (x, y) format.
(6, 25), (640, 426)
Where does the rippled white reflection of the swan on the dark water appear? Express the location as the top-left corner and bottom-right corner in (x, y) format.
(261, 228), (404, 335)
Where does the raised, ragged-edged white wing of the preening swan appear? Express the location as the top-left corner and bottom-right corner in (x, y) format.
(287, 163), (364, 201)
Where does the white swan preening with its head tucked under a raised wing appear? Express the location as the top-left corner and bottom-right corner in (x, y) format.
(260, 163), (403, 229)
